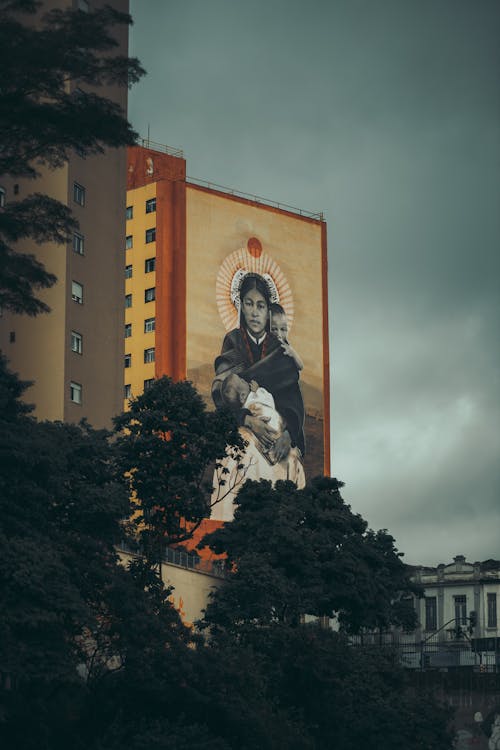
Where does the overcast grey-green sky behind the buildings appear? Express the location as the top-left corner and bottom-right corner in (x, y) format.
(129, 0), (500, 565)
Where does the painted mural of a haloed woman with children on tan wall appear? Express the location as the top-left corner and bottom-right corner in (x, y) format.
(186, 186), (329, 520)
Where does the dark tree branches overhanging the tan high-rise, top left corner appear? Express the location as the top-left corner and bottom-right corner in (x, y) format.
(0, 0), (144, 315)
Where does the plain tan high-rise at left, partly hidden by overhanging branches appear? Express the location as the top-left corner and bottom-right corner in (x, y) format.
(0, 0), (129, 427)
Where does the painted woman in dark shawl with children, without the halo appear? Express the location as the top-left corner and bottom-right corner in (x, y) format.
(212, 273), (305, 521)
